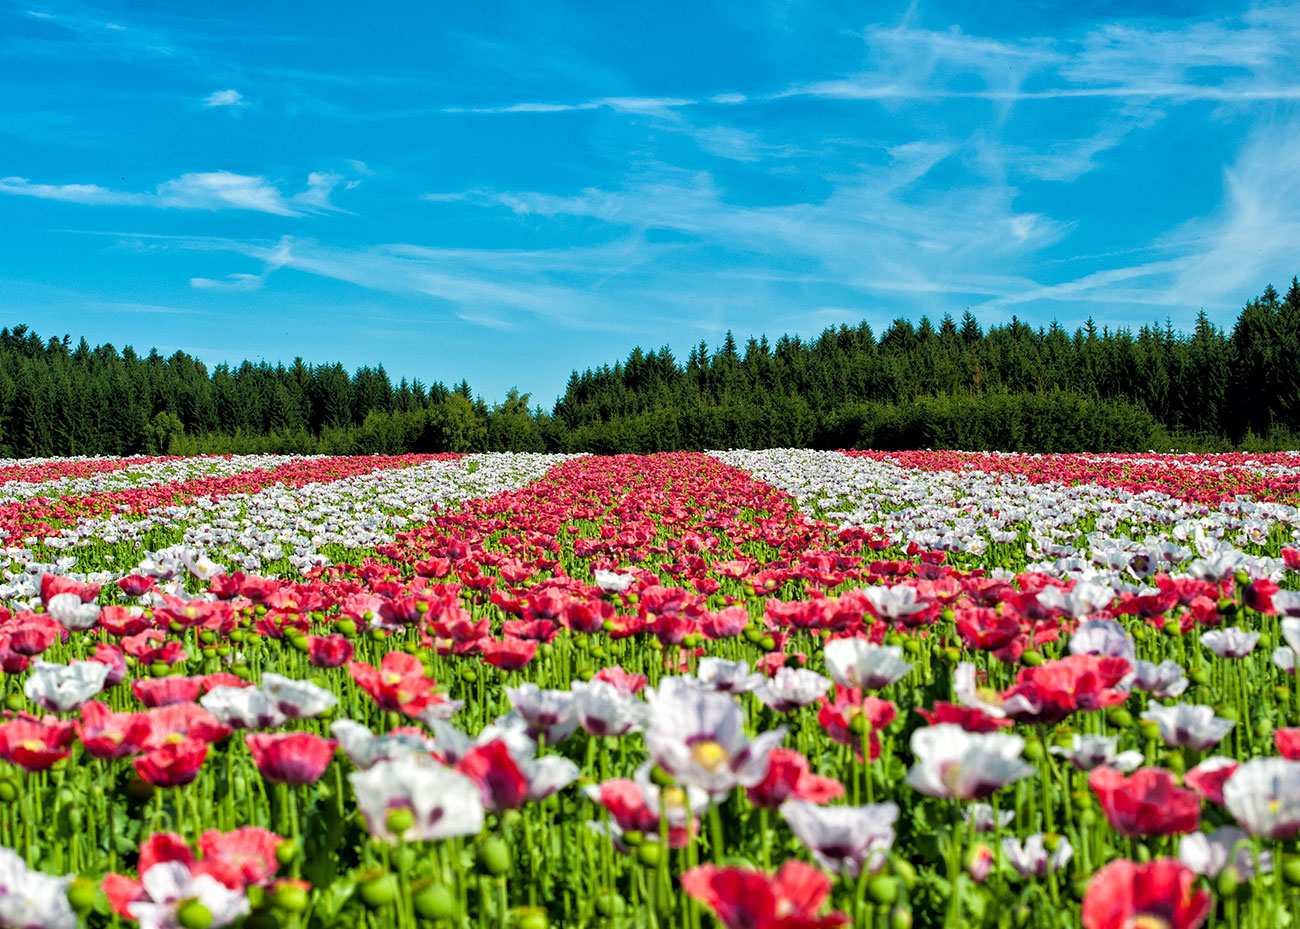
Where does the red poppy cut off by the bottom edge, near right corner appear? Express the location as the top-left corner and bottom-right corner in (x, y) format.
(1082, 859), (1213, 929)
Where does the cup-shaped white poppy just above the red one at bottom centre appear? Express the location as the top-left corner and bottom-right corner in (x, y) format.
(781, 800), (898, 878)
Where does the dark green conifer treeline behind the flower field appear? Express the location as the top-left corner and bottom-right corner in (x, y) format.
(0, 279), (1300, 457)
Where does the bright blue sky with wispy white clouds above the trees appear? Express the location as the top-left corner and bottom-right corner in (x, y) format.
(0, 0), (1300, 405)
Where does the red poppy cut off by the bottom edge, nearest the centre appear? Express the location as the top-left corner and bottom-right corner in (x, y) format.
(681, 860), (852, 929)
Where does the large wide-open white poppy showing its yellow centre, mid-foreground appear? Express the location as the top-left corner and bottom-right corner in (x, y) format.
(645, 677), (785, 794)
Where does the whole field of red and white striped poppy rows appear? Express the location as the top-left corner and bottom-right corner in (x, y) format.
(0, 451), (1300, 929)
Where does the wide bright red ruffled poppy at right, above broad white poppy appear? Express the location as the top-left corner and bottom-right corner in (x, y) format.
(1002, 655), (1132, 725)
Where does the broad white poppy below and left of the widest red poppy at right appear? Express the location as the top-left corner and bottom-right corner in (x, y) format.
(907, 722), (1034, 800)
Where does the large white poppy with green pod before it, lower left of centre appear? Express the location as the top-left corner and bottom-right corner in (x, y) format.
(347, 755), (484, 842)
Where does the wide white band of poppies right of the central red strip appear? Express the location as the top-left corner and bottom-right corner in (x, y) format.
(714, 448), (1300, 592)
